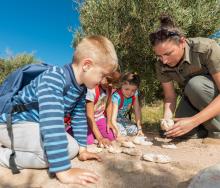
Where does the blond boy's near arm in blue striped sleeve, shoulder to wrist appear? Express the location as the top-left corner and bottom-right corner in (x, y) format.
(36, 71), (71, 173)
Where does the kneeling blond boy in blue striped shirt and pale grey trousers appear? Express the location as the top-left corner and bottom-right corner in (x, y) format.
(0, 36), (118, 185)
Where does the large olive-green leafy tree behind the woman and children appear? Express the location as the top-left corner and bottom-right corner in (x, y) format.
(73, 0), (220, 102)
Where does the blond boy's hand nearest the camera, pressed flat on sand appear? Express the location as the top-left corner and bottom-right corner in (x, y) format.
(56, 168), (99, 185)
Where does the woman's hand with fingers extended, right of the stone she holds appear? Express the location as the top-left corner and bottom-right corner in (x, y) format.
(165, 117), (198, 137)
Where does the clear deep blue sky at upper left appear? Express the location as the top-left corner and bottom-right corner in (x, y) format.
(0, 0), (79, 65)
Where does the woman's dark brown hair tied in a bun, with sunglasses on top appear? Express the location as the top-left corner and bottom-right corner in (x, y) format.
(149, 14), (184, 46)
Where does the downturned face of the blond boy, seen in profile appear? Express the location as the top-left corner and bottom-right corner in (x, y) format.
(83, 65), (112, 89)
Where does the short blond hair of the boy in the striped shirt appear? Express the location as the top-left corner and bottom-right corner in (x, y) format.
(73, 35), (118, 71)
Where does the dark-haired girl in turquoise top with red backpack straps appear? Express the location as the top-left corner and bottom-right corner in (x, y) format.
(112, 72), (143, 137)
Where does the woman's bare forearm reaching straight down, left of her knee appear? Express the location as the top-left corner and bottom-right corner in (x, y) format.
(162, 82), (176, 119)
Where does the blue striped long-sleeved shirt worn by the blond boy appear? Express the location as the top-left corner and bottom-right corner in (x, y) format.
(0, 65), (87, 172)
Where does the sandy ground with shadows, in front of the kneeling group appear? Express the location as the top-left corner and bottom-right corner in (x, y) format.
(0, 134), (220, 188)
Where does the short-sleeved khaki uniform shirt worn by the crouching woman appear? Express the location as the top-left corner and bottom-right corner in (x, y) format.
(156, 37), (220, 85)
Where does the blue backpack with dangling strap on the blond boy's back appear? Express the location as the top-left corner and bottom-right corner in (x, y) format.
(0, 64), (72, 174)
